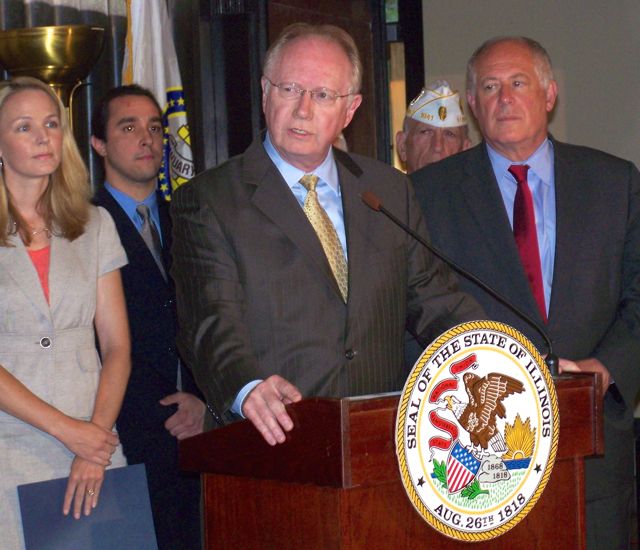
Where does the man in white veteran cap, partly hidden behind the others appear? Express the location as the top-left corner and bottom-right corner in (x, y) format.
(396, 80), (471, 174)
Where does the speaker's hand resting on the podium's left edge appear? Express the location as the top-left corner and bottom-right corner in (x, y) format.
(242, 374), (302, 445)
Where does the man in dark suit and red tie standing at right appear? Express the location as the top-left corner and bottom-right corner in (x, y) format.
(412, 37), (640, 549)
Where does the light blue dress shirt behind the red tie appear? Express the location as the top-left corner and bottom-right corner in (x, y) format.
(486, 139), (556, 313)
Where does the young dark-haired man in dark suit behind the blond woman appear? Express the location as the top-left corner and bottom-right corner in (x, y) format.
(91, 85), (206, 550)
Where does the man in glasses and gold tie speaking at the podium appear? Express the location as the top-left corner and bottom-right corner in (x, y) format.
(172, 24), (482, 450)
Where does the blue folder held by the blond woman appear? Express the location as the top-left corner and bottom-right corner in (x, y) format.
(18, 464), (158, 550)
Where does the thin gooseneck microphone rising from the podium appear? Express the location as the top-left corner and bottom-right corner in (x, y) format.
(360, 191), (558, 377)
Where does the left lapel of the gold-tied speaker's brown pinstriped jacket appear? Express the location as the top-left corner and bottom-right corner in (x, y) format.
(243, 138), (342, 300)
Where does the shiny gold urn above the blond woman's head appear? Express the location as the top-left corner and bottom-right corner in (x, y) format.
(0, 25), (104, 110)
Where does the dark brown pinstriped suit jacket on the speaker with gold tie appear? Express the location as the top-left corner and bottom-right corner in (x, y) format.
(172, 140), (482, 422)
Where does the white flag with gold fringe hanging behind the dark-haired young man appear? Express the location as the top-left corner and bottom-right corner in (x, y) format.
(122, 0), (194, 200)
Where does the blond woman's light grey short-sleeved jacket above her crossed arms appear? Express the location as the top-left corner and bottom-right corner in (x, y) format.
(0, 207), (127, 422)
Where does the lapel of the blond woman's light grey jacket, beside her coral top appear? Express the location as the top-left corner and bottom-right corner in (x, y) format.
(0, 235), (54, 321)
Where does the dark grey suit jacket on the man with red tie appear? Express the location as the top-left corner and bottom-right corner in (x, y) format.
(412, 140), (640, 499)
